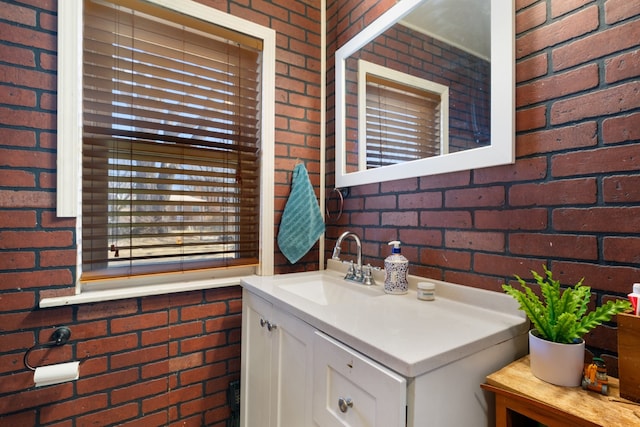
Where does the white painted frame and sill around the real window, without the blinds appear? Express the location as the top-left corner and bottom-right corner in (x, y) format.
(39, 0), (276, 307)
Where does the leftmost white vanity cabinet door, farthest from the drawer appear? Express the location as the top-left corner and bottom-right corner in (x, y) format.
(240, 290), (276, 427)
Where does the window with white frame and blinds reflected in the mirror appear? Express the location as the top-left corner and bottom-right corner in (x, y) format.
(358, 60), (449, 169)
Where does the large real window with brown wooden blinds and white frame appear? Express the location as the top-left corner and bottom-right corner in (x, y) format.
(53, 0), (275, 304)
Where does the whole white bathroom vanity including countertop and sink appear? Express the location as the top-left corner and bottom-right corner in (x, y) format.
(240, 270), (528, 427)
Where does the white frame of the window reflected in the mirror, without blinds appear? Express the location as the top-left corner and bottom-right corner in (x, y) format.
(358, 59), (449, 170)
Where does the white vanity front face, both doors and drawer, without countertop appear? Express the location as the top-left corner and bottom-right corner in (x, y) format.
(240, 290), (407, 427)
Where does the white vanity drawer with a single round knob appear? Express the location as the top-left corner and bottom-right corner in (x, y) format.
(313, 331), (407, 427)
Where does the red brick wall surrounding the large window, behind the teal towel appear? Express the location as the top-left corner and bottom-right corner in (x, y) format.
(0, 0), (320, 427)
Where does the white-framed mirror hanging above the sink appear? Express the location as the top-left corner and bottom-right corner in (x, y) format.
(335, 0), (515, 188)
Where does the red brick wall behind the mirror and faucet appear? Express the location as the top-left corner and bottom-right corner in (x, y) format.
(326, 0), (640, 374)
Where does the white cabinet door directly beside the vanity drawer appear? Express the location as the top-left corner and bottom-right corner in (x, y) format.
(274, 309), (314, 427)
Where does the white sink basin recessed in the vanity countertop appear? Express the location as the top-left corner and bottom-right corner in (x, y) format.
(277, 274), (384, 305)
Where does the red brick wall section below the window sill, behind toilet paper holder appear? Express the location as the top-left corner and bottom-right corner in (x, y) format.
(0, 287), (242, 426)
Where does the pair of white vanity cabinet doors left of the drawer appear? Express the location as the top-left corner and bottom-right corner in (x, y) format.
(240, 290), (314, 427)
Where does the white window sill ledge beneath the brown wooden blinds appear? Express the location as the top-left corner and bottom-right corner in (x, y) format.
(39, 277), (248, 308)
